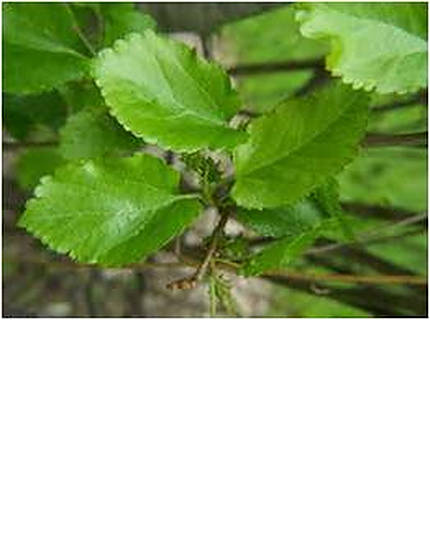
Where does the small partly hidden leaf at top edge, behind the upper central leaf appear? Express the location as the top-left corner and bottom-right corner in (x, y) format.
(100, 2), (156, 47)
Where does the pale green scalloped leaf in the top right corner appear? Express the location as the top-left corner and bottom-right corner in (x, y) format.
(297, 2), (427, 93)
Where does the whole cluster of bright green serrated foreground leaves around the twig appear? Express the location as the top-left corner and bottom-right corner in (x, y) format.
(3, 2), (427, 316)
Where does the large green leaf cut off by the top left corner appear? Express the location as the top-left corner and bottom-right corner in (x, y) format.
(3, 2), (89, 93)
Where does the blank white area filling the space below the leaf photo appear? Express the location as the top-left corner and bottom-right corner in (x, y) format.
(0, 319), (430, 560)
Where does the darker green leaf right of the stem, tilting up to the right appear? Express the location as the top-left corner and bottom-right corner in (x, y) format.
(232, 83), (369, 209)
